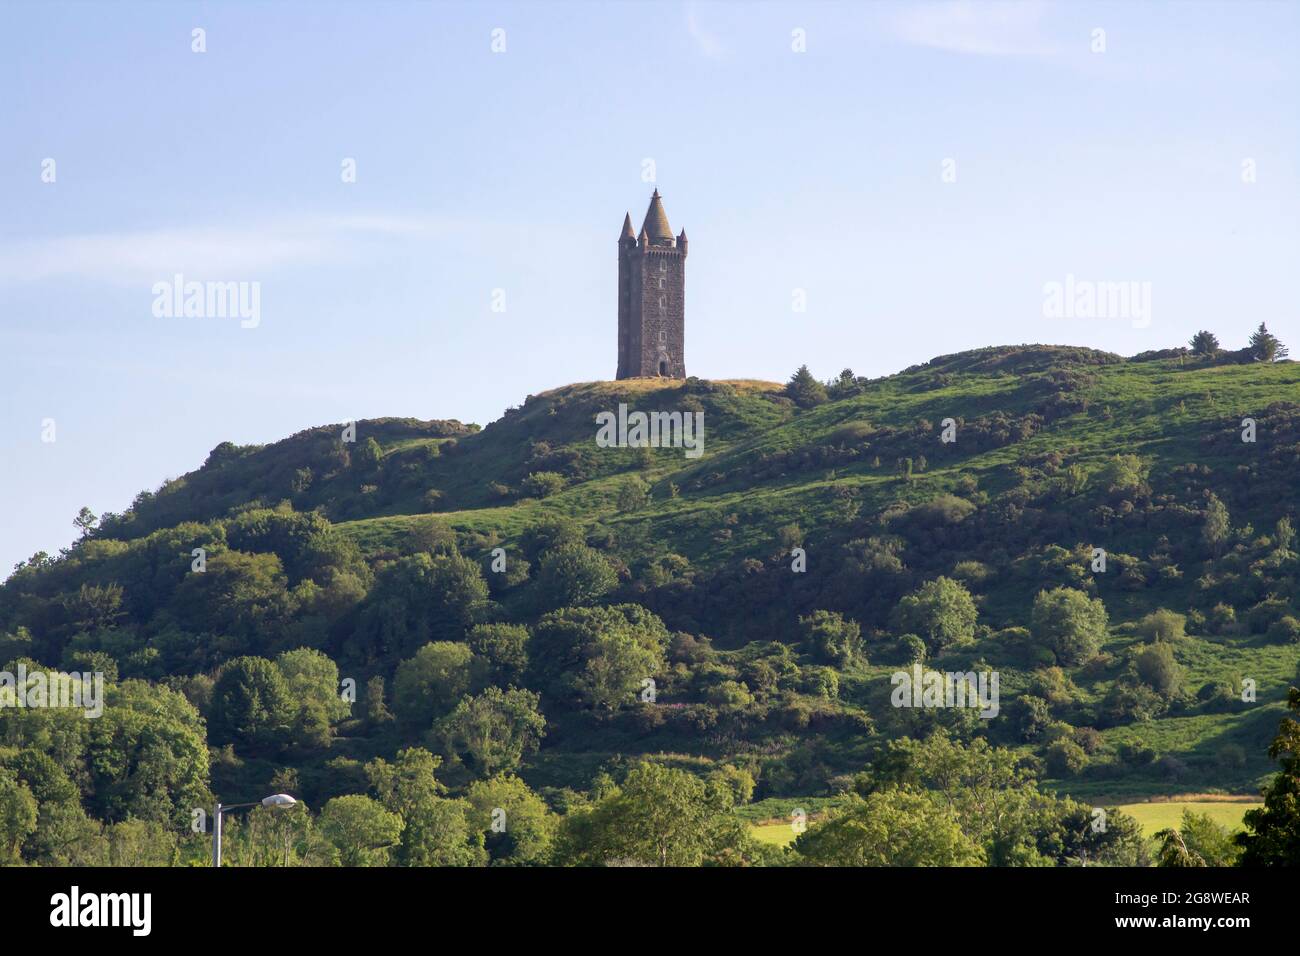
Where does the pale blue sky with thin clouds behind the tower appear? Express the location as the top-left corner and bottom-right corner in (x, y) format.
(0, 1), (1300, 576)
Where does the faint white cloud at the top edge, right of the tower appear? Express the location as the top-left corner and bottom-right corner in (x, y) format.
(893, 0), (1057, 56)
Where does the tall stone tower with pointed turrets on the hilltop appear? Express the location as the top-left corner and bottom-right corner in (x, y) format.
(618, 190), (686, 378)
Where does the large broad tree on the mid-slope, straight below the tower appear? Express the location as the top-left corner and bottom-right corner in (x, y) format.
(529, 605), (668, 710)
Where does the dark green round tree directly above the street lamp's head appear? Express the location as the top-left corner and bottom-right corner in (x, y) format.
(208, 657), (299, 753)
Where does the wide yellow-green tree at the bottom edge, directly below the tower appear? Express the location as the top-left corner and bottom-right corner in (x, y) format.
(559, 761), (758, 866)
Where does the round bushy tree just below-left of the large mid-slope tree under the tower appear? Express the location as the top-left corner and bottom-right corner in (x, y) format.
(441, 687), (546, 777)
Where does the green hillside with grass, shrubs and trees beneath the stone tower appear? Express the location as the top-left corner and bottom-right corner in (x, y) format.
(0, 346), (1300, 868)
